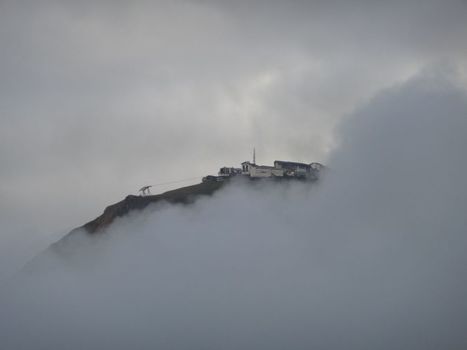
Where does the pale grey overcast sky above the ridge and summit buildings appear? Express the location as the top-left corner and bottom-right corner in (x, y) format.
(0, 0), (467, 277)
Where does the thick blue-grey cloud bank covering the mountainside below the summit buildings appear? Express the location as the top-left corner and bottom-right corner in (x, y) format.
(0, 72), (467, 350)
